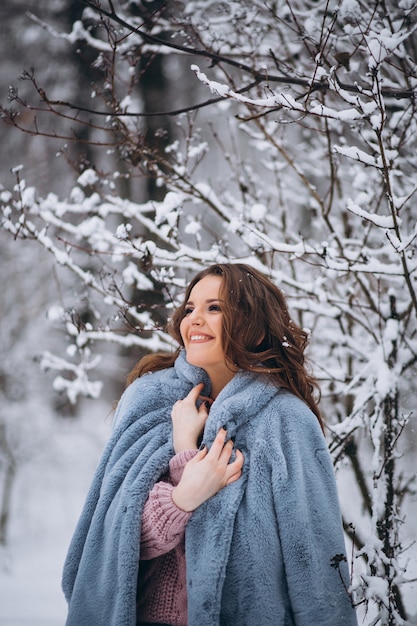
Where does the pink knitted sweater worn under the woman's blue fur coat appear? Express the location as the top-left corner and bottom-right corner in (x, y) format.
(137, 450), (197, 626)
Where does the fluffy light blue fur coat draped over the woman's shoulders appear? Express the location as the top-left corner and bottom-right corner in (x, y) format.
(63, 351), (356, 626)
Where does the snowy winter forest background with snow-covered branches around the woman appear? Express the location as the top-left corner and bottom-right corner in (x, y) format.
(0, 0), (417, 626)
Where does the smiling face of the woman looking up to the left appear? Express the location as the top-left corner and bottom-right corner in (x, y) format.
(180, 275), (233, 384)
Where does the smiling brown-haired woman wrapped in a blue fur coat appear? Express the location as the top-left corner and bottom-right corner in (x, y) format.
(63, 264), (356, 626)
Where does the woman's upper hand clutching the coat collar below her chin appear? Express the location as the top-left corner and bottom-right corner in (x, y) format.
(171, 383), (210, 454)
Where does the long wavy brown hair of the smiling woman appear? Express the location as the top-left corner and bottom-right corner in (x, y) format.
(128, 263), (323, 428)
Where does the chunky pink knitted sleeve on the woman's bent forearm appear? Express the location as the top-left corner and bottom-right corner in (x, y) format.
(140, 450), (197, 561)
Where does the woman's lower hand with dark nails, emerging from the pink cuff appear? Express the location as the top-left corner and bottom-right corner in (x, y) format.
(172, 428), (244, 511)
